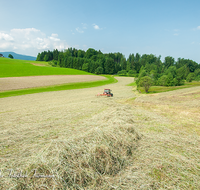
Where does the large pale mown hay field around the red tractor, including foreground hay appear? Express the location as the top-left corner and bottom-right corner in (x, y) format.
(0, 77), (200, 189)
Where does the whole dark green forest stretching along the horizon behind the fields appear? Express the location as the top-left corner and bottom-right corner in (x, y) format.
(36, 48), (200, 86)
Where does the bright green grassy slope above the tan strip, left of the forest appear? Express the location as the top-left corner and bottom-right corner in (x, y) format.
(0, 58), (92, 77)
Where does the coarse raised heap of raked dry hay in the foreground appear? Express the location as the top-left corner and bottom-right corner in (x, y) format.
(12, 126), (140, 189)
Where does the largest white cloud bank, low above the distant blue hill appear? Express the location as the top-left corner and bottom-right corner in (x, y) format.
(0, 28), (69, 56)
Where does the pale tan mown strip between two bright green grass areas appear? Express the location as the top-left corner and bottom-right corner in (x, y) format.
(0, 75), (105, 91)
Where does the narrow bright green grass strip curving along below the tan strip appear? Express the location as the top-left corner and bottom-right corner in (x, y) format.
(0, 75), (118, 98)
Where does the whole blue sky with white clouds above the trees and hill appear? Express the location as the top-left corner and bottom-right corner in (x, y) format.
(0, 0), (200, 63)
